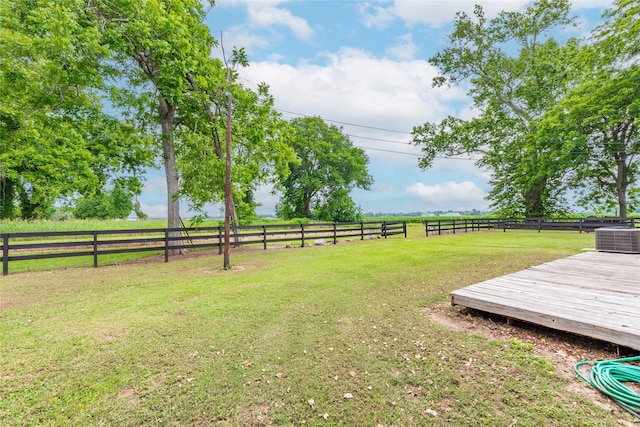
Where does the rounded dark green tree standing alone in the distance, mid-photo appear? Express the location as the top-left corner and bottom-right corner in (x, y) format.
(276, 117), (372, 221)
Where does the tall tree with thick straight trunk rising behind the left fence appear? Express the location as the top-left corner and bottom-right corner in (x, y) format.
(89, 0), (215, 236)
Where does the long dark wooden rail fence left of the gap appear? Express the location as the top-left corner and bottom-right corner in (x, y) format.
(0, 221), (407, 276)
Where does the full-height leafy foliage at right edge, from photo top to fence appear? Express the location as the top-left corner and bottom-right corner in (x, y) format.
(539, 0), (640, 217)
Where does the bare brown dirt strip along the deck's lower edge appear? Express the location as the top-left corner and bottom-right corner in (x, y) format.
(422, 302), (639, 426)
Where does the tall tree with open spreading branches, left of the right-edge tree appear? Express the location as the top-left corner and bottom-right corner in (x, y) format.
(413, 0), (578, 216)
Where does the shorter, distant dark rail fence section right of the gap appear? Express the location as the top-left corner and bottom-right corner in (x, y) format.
(422, 217), (636, 236)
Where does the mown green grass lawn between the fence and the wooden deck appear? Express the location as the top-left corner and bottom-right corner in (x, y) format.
(0, 228), (632, 426)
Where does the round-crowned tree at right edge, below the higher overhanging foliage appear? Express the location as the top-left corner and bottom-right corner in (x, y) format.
(540, 65), (640, 218)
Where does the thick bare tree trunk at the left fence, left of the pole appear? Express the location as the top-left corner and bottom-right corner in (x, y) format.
(158, 95), (181, 254)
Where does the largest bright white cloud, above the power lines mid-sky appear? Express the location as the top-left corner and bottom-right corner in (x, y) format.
(241, 48), (467, 165)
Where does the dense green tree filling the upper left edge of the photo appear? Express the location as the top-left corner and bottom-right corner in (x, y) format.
(0, 0), (148, 218)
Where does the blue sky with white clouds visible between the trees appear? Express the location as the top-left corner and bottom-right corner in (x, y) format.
(140, 0), (612, 217)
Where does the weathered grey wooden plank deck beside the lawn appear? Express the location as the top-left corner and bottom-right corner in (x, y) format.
(451, 252), (640, 350)
